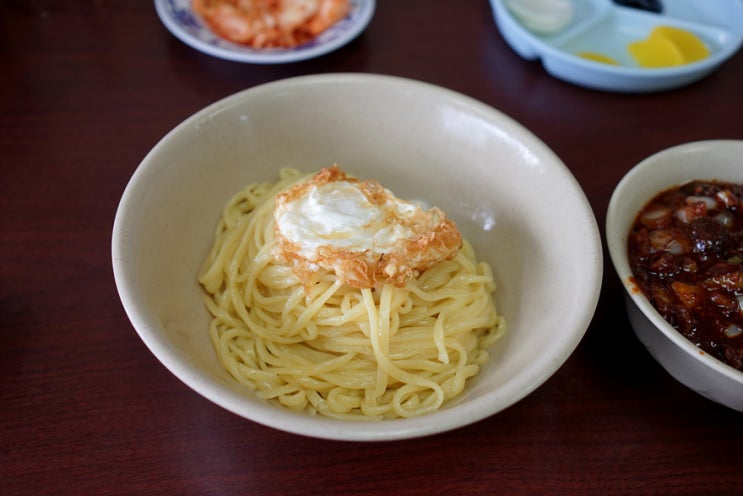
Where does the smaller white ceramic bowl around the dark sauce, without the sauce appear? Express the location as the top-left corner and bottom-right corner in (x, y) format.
(606, 140), (743, 411)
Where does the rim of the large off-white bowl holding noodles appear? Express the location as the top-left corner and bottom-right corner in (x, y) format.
(112, 73), (603, 441)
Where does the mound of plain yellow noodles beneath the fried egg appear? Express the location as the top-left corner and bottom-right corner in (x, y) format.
(199, 169), (506, 419)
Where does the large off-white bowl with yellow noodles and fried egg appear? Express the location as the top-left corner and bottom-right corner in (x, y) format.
(112, 74), (602, 441)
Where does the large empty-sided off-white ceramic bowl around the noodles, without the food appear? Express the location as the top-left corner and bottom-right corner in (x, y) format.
(112, 74), (602, 441)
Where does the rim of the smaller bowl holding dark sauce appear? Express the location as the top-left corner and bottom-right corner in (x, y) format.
(606, 139), (743, 384)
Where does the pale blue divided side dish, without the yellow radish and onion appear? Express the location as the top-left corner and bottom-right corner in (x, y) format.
(490, 0), (743, 93)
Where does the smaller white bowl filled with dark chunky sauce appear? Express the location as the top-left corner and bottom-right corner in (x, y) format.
(606, 140), (743, 411)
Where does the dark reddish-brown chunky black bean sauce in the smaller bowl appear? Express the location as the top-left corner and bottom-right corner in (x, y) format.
(628, 181), (743, 370)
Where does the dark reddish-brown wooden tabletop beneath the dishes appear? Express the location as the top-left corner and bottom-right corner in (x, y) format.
(0, 0), (743, 496)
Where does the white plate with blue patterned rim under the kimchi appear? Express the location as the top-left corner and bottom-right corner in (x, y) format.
(155, 0), (376, 64)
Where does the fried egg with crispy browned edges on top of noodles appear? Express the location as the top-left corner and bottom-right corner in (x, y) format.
(274, 165), (462, 288)
